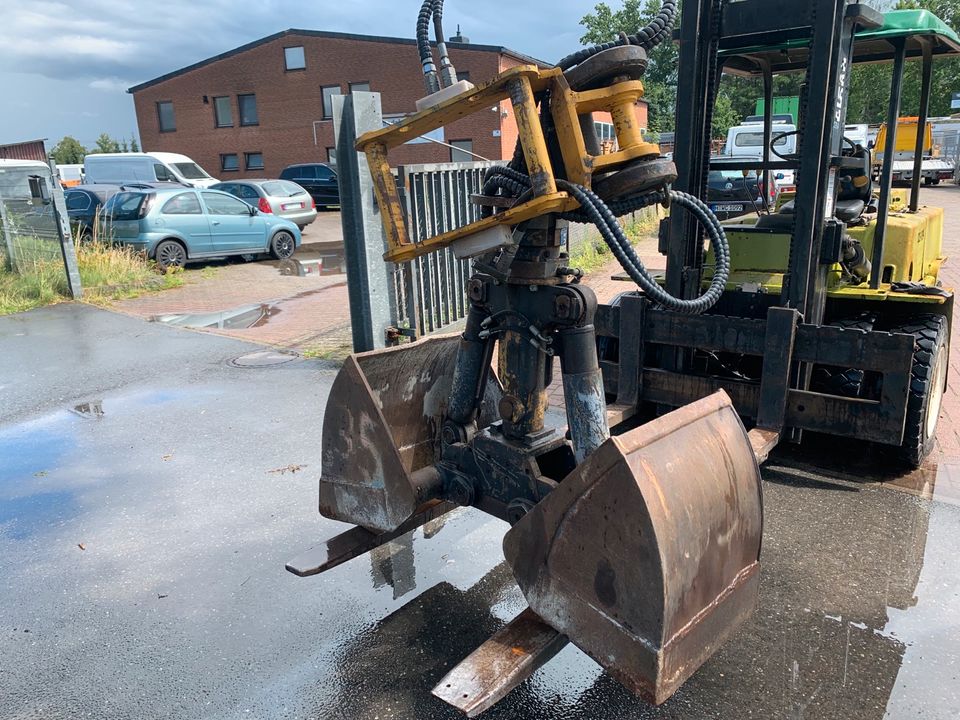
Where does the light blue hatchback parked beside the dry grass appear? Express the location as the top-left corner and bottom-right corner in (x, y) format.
(104, 188), (301, 269)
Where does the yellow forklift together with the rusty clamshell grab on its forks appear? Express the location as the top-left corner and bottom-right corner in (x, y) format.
(287, 0), (960, 717)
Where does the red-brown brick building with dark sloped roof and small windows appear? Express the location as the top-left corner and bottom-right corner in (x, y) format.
(128, 30), (646, 178)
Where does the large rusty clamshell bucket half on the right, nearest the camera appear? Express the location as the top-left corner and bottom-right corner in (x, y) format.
(503, 393), (763, 704)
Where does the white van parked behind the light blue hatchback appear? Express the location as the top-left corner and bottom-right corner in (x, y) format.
(83, 152), (220, 188)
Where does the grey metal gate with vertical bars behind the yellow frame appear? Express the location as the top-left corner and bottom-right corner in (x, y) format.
(393, 162), (494, 339)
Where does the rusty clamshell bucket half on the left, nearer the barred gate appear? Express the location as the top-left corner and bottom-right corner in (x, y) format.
(320, 335), (501, 532)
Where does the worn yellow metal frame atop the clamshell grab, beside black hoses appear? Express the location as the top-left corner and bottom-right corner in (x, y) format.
(357, 65), (660, 263)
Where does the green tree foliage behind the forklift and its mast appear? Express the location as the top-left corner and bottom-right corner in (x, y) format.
(580, 0), (960, 138)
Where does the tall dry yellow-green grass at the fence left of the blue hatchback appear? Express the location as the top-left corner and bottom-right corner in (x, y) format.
(0, 226), (183, 315)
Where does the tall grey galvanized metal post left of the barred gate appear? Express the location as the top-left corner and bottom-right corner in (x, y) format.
(333, 92), (396, 352)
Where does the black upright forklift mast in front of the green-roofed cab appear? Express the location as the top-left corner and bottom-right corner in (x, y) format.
(664, 0), (883, 325)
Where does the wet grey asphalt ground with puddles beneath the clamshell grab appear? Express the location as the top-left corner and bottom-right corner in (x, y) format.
(0, 305), (960, 720)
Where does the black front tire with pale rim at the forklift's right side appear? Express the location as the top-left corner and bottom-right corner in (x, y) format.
(890, 315), (950, 468)
